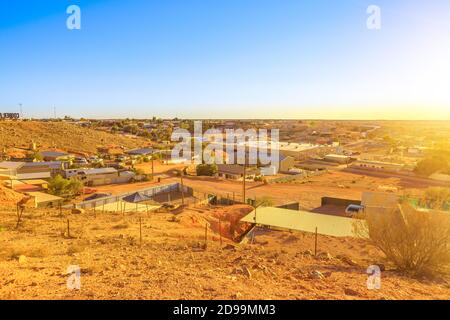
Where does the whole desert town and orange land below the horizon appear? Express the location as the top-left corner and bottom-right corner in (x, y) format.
(0, 117), (450, 299)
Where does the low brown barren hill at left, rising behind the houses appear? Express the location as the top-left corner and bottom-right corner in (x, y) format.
(0, 121), (150, 154)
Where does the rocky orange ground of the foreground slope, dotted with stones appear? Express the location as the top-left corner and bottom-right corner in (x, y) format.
(0, 208), (450, 299)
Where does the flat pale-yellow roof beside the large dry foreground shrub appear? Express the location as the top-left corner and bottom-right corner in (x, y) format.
(241, 207), (358, 237)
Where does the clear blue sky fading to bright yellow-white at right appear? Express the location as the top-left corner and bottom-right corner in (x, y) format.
(0, 0), (450, 119)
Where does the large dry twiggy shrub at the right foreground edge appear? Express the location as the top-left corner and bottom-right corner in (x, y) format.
(356, 204), (450, 276)
